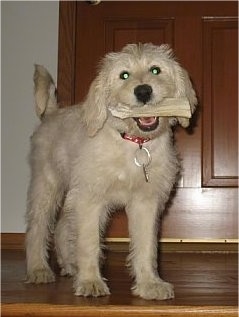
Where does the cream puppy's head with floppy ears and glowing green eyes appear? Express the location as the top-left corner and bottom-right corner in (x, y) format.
(83, 44), (197, 138)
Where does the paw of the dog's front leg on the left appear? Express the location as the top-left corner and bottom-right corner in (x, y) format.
(75, 279), (110, 297)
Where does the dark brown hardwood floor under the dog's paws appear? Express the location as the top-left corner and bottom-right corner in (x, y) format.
(2, 250), (238, 317)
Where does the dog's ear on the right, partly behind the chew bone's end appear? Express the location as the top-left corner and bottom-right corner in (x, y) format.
(175, 63), (197, 128)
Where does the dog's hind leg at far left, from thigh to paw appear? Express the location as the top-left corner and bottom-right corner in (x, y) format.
(26, 174), (62, 284)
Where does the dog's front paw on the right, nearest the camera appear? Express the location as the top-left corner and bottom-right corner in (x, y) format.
(132, 280), (174, 300)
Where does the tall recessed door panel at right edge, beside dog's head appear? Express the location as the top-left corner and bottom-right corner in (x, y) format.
(203, 17), (238, 187)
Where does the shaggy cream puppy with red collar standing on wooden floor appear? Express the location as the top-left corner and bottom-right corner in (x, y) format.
(26, 43), (197, 300)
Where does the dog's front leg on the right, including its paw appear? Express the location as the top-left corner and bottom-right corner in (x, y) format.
(126, 199), (174, 300)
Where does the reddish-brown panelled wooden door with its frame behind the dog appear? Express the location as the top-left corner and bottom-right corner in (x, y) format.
(58, 1), (238, 241)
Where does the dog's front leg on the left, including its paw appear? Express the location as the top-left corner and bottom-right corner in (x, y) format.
(70, 197), (110, 297)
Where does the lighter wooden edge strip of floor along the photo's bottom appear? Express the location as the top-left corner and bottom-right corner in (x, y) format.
(2, 304), (237, 317)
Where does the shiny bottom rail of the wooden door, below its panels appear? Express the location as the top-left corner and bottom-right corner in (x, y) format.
(108, 188), (238, 240)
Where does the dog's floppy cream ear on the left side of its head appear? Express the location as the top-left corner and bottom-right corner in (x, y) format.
(82, 74), (107, 137)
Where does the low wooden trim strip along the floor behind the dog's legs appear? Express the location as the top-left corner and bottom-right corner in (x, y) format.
(1, 233), (238, 253)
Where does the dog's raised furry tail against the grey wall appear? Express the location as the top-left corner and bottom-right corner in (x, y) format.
(33, 65), (58, 120)
